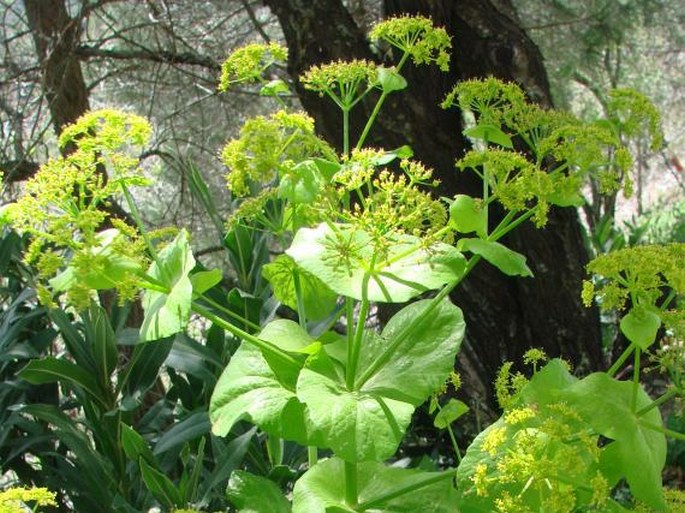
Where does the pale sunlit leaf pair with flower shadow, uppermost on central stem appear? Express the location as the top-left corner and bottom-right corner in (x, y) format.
(286, 223), (466, 302)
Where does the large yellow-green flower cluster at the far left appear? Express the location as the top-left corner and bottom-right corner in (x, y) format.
(7, 109), (152, 307)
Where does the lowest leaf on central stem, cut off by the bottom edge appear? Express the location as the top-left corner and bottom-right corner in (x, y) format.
(293, 458), (459, 513)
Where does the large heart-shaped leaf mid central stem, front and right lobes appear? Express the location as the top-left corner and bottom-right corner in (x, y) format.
(297, 300), (464, 461)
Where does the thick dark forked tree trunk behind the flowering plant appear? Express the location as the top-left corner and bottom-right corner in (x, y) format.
(265, 0), (602, 413)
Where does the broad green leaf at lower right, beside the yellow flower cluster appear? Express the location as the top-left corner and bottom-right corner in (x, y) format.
(564, 372), (666, 511)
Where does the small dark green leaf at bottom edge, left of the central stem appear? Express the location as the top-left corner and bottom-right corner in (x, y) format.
(226, 470), (290, 513)
